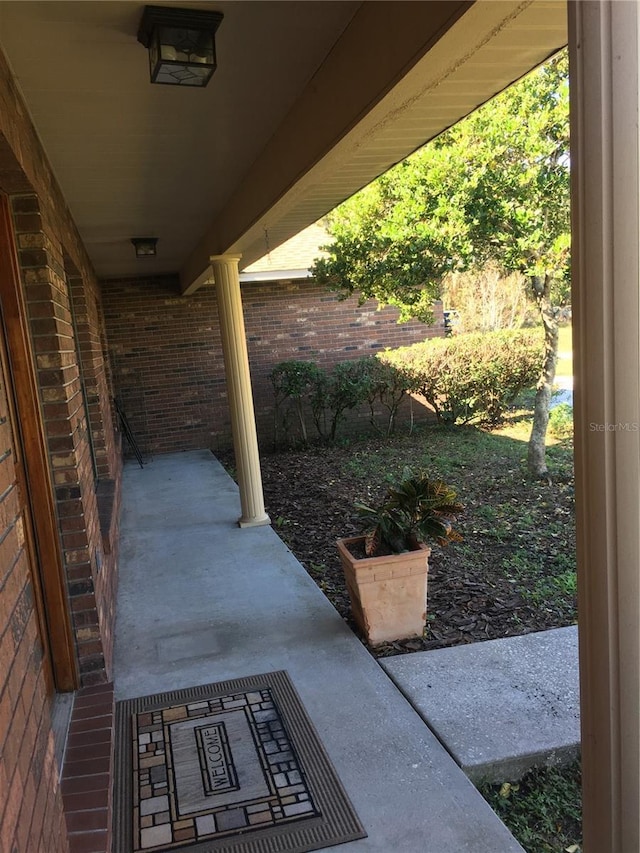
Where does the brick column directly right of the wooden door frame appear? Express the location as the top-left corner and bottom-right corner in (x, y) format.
(11, 195), (115, 686)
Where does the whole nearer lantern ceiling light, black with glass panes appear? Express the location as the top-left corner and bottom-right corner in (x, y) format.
(138, 6), (223, 88)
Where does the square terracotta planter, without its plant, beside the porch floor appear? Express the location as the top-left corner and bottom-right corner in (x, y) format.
(336, 536), (431, 645)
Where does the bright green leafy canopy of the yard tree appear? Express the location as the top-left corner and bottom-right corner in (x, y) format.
(313, 52), (570, 321)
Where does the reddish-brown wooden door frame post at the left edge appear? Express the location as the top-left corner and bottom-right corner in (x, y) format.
(0, 193), (78, 692)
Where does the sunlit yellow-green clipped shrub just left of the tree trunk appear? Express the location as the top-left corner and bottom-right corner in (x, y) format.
(379, 329), (543, 424)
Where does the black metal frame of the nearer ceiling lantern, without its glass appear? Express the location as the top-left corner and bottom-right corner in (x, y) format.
(138, 6), (224, 89)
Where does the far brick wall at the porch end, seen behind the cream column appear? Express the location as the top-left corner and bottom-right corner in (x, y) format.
(101, 276), (442, 453)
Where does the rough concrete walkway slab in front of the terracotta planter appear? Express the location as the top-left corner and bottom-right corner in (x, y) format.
(381, 625), (580, 782)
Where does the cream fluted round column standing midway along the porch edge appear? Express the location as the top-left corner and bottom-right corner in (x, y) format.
(210, 255), (270, 527)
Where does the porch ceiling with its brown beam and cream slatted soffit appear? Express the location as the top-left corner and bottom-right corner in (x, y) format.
(0, 0), (566, 289)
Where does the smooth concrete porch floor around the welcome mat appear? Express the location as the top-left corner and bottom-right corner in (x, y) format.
(114, 451), (522, 853)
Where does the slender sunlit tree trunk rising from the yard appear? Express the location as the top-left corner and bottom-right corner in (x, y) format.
(527, 274), (558, 479)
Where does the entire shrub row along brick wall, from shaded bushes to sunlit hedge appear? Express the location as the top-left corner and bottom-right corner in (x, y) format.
(271, 329), (543, 445)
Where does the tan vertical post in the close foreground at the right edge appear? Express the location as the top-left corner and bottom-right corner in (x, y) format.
(569, 0), (640, 853)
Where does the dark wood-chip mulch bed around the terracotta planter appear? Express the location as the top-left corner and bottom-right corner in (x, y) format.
(218, 430), (576, 657)
